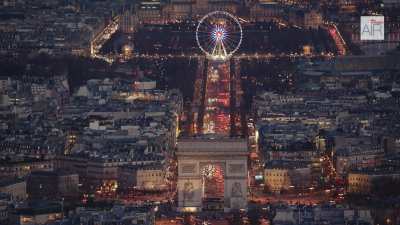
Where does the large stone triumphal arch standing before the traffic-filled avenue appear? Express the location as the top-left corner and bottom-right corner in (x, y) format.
(177, 138), (248, 212)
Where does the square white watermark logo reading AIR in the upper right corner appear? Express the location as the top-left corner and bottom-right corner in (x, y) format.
(360, 16), (385, 41)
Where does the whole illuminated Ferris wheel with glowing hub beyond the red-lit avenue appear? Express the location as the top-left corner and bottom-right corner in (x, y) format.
(196, 11), (243, 61)
